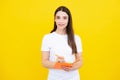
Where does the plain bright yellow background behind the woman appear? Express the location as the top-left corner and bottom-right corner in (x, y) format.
(0, 0), (120, 80)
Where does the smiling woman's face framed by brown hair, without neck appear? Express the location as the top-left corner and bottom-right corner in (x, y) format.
(55, 11), (68, 30)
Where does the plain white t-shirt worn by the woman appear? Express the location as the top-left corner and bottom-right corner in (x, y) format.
(41, 32), (82, 80)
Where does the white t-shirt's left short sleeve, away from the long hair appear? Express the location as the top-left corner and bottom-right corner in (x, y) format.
(41, 35), (50, 51)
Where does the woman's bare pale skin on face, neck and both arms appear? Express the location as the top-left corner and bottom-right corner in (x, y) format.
(42, 11), (83, 71)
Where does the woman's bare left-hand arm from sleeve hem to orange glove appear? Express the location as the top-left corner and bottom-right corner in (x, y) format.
(42, 51), (55, 68)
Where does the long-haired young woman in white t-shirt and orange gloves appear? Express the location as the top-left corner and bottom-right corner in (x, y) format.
(41, 6), (82, 80)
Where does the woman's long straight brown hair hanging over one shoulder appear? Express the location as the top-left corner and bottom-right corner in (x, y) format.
(50, 6), (77, 53)
